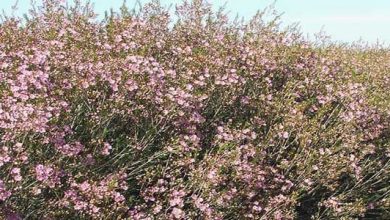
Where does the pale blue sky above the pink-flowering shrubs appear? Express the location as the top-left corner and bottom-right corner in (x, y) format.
(0, 0), (390, 44)
